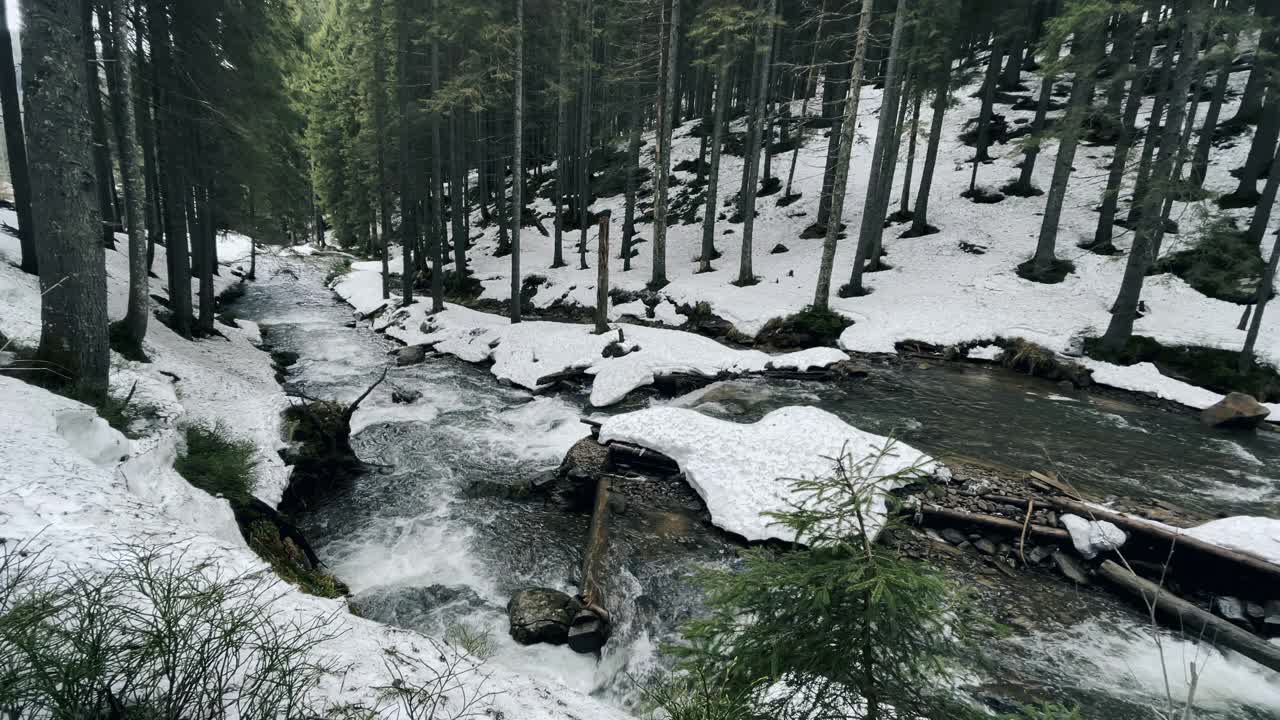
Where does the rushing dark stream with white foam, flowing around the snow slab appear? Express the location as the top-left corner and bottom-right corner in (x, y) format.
(232, 260), (1280, 720)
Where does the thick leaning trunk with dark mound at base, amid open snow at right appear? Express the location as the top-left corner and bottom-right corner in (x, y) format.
(1019, 32), (1102, 282)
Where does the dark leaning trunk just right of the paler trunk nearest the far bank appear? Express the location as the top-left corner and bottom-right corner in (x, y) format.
(841, 0), (911, 297)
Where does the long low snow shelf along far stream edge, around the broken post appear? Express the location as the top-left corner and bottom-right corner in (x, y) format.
(333, 271), (849, 407)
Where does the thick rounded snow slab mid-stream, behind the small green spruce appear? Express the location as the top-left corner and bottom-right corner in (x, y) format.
(600, 407), (947, 542)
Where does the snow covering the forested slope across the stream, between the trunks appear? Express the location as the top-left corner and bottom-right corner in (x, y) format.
(327, 53), (1280, 410)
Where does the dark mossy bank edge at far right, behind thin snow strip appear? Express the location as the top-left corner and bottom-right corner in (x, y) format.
(1084, 336), (1280, 402)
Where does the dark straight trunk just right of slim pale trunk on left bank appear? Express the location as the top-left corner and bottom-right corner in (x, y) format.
(147, 0), (191, 337)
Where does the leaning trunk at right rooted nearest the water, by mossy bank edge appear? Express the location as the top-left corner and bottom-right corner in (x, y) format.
(1102, 0), (1204, 352)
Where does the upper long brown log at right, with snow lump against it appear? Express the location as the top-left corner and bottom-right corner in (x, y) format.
(982, 495), (1280, 589)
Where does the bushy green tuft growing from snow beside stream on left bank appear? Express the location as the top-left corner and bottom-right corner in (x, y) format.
(174, 423), (257, 503)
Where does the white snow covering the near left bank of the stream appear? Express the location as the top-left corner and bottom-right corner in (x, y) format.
(0, 230), (627, 720)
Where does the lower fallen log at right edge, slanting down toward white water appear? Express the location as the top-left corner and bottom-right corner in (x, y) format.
(1098, 560), (1280, 671)
